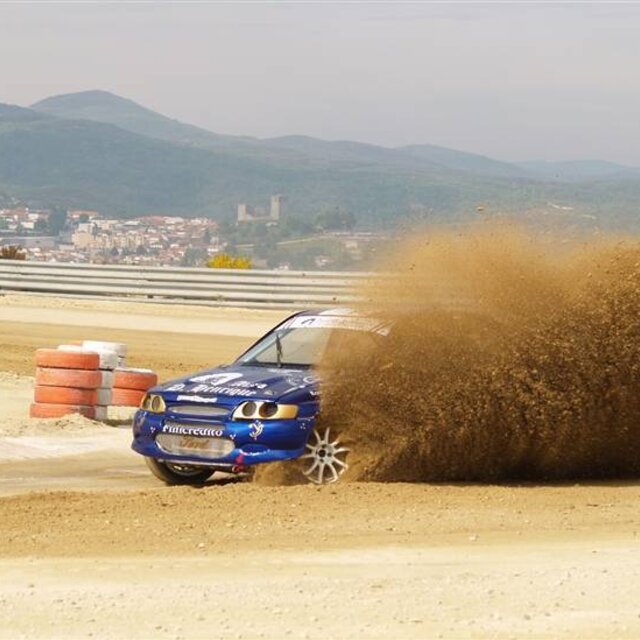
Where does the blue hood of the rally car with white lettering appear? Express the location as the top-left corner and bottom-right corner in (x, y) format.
(151, 365), (318, 400)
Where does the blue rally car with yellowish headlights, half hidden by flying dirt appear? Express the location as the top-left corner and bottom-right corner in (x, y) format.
(132, 309), (388, 484)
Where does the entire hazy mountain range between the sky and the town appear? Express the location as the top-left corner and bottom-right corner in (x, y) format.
(0, 91), (640, 227)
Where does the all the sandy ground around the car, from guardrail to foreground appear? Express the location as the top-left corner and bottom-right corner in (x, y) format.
(0, 297), (640, 639)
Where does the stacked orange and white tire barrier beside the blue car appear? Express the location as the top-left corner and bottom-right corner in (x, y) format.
(30, 340), (158, 421)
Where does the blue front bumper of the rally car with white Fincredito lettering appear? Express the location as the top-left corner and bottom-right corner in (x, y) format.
(131, 409), (314, 469)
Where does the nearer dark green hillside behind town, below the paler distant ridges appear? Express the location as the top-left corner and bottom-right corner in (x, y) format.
(0, 99), (552, 221)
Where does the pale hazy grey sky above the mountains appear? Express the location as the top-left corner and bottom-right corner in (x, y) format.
(0, 1), (640, 165)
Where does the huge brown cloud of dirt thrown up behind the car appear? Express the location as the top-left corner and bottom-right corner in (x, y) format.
(321, 228), (640, 482)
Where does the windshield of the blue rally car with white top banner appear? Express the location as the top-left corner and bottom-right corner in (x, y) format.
(237, 316), (380, 369)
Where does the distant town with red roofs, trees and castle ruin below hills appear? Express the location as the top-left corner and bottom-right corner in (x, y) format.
(0, 195), (383, 270)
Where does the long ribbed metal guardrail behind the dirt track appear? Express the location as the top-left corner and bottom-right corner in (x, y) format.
(0, 260), (372, 309)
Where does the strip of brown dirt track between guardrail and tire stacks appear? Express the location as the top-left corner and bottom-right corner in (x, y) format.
(0, 296), (287, 380)
